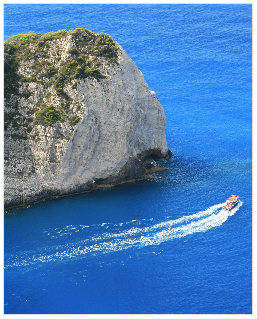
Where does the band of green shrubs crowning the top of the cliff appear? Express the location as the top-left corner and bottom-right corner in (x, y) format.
(4, 28), (118, 98)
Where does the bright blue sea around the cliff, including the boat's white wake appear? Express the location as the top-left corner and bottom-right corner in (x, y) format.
(4, 4), (252, 314)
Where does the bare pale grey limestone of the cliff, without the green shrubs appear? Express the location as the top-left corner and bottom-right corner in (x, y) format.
(5, 30), (171, 208)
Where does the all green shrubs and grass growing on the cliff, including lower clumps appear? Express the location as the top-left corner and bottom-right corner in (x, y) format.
(4, 28), (118, 132)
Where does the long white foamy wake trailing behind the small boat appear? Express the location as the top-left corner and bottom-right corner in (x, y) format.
(5, 201), (243, 268)
